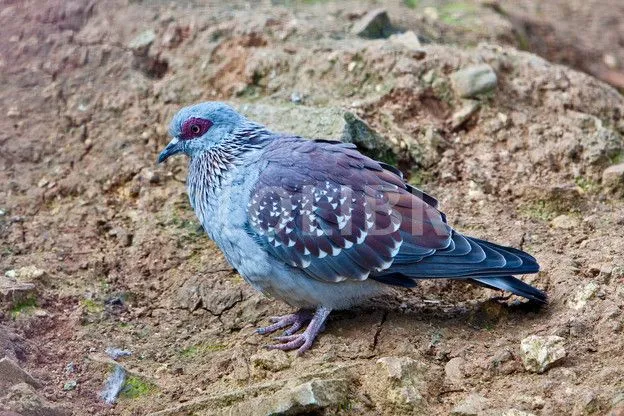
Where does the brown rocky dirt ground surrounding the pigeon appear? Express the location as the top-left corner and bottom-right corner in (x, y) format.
(0, 0), (624, 416)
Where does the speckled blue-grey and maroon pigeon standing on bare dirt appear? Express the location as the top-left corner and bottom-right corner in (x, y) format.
(158, 102), (546, 354)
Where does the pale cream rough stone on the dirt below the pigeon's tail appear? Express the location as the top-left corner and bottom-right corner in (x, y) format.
(520, 335), (567, 373)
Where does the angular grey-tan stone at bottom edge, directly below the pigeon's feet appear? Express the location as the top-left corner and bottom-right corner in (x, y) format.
(266, 379), (348, 416)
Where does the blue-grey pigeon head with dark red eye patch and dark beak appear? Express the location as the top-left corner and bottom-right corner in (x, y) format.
(158, 101), (245, 163)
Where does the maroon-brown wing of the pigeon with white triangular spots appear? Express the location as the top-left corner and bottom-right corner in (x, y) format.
(248, 137), (452, 282)
